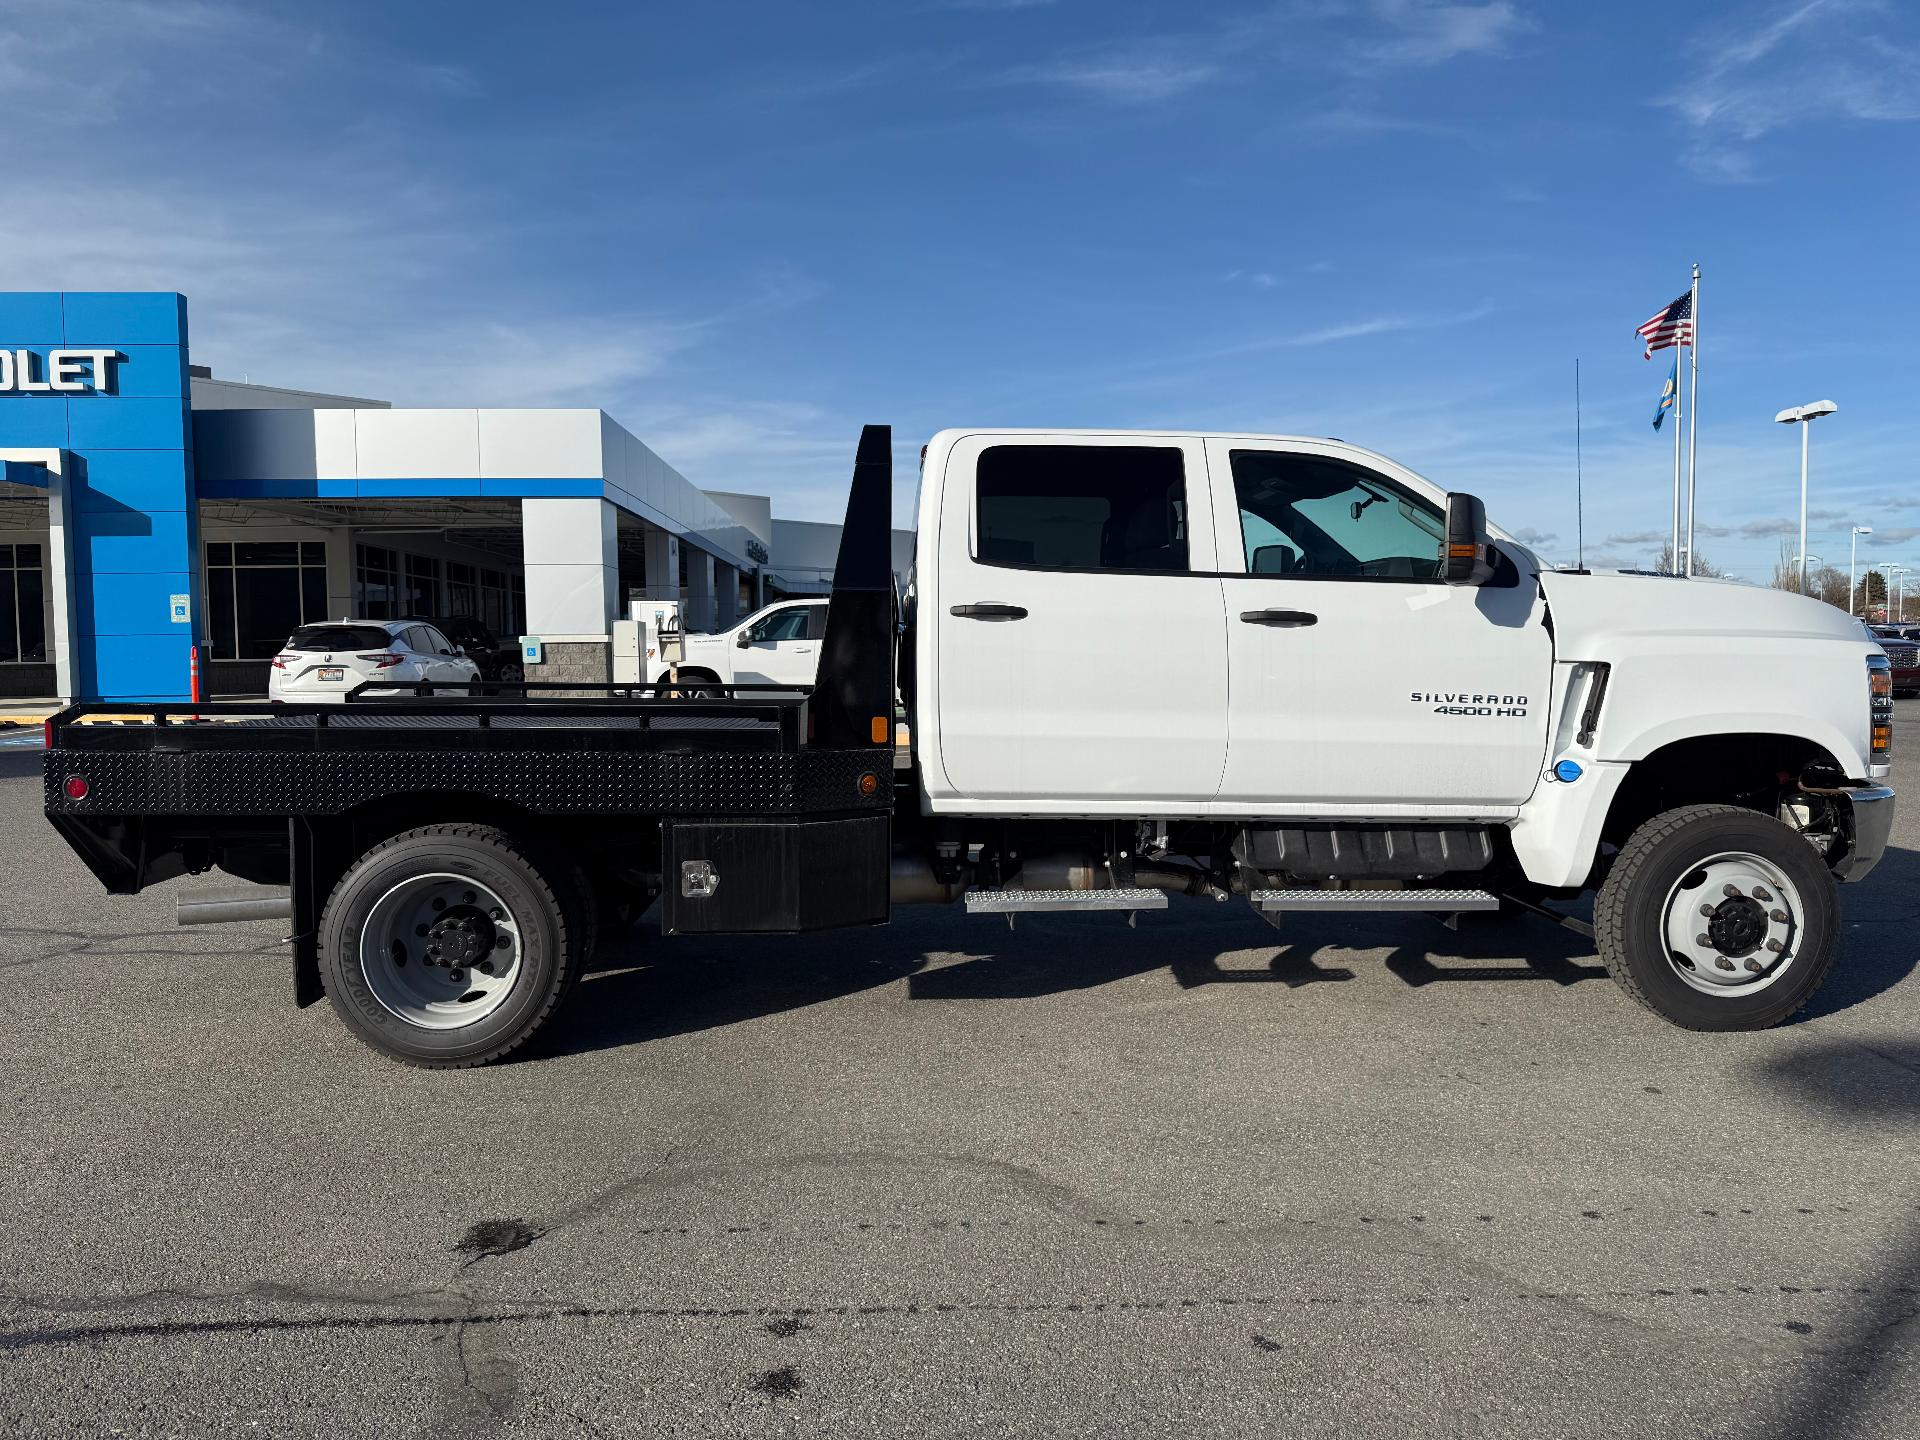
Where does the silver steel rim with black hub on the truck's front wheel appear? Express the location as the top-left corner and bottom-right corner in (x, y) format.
(1661, 851), (1807, 1000)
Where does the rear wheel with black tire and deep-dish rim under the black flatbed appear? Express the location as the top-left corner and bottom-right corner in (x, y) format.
(319, 826), (584, 1069)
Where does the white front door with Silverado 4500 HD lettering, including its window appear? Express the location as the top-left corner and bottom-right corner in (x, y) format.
(1206, 440), (1553, 814)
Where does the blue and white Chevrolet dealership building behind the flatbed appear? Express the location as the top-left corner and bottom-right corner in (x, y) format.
(0, 292), (912, 701)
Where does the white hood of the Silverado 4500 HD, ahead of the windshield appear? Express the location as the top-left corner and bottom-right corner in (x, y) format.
(1540, 570), (1866, 660)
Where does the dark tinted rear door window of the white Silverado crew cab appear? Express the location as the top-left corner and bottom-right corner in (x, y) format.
(973, 445), (1187, 572)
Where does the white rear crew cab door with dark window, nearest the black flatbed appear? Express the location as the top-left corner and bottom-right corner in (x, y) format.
(918, 434), (1227, 814)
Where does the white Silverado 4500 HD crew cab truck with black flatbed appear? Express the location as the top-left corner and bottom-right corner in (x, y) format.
(46, 426), (1893, 1066)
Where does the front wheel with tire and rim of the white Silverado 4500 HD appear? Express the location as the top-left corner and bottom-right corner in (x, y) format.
(1594, 804), (1839, 1031)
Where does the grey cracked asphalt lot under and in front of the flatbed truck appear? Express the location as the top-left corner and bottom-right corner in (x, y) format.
(0, 703), (1920, 1440)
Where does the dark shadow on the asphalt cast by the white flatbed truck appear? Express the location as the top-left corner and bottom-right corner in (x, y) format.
(538, 851), (1920, 1054)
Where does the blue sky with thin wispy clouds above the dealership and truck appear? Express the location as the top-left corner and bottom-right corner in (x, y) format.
(0, 0), (1920, 578)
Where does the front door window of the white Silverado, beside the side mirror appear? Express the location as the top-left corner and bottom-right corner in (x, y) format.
(1231, 449), (1446, 580)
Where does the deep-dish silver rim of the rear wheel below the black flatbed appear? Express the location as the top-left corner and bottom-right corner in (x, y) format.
(359, 874), (526, 1029)
